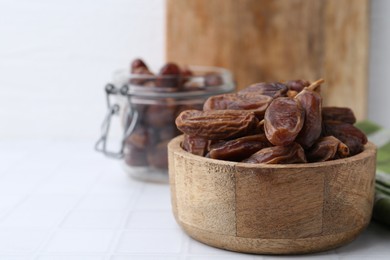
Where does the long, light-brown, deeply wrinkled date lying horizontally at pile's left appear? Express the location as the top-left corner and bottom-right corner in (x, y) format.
(176, 110), (259, 140)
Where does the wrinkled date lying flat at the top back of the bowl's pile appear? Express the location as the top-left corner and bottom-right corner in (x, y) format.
(237, 82), (288, 98)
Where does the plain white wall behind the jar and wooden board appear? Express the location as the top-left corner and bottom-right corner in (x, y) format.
(0, 0), (390, 139)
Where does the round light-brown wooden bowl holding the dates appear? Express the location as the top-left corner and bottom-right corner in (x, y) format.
(168, 136), (376, 254)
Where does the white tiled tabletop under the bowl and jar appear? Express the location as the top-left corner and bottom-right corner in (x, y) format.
(0, 137), (390, 260)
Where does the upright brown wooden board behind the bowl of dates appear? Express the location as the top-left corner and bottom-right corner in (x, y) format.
(166, 0), (369, 119)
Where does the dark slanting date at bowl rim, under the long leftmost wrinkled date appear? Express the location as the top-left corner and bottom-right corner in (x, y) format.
(208, 134), (271, 162)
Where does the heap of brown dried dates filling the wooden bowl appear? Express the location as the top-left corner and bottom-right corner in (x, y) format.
(176, 79), (367, 164)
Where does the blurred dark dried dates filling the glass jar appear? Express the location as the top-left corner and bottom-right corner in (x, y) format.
(123, 59), (234, 171)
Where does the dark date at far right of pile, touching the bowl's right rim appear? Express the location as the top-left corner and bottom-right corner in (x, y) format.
(323, 121), (367, 155)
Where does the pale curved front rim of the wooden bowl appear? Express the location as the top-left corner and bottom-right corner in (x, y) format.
(168, 135), (377, 169)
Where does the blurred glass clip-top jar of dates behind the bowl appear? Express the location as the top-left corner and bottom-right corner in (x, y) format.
(95, 66), (235, 182)
